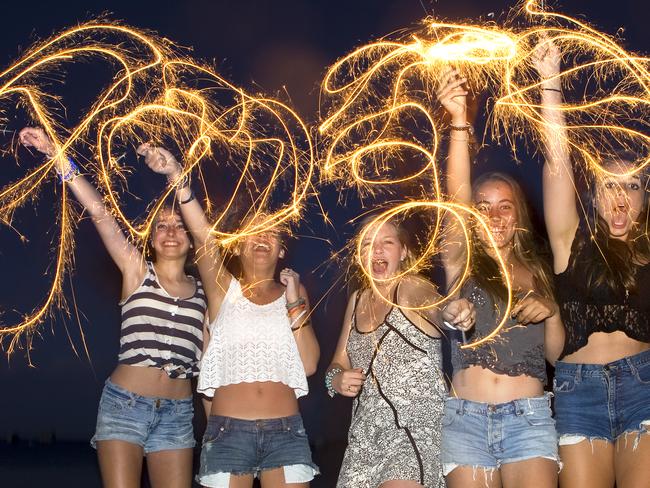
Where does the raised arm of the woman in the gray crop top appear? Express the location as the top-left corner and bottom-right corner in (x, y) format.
(437, 70), (472, 286)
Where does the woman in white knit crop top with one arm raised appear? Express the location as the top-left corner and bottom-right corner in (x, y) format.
(145, 143), (320, 488)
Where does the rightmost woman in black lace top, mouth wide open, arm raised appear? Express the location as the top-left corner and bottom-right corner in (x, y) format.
(537, 42), (650, 488)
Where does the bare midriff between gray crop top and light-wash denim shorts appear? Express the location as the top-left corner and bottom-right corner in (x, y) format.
(450, 366), (544, 404)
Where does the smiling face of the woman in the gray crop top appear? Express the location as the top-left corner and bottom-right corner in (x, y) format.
(474, 179), (519, 249)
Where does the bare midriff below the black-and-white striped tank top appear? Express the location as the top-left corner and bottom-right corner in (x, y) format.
(111, 364), (192, 400)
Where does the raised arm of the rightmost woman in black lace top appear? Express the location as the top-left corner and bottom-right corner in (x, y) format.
(533, 39), (580, 273)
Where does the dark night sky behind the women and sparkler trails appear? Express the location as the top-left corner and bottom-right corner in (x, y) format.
(0, 0), (649, 448)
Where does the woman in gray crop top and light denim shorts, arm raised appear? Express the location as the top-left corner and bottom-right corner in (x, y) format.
(438, 65), (564, 488)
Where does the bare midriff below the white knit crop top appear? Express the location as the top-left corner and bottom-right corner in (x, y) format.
(210, 381), (298, 420)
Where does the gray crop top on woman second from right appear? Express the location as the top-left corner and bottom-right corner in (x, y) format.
(451, 279), (546, 384)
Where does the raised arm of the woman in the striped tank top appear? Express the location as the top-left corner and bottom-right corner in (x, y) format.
(19, 127), (146, 296)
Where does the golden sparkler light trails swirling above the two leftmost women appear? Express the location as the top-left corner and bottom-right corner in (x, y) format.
(0, 22), (314, 354)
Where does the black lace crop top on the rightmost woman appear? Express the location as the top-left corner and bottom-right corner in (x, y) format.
(555, 229), (650, 359)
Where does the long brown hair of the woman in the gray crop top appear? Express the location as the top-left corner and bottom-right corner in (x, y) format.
(470, 172), (553, 301)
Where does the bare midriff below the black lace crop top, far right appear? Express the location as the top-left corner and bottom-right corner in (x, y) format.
(562, 331), (650, 364)
